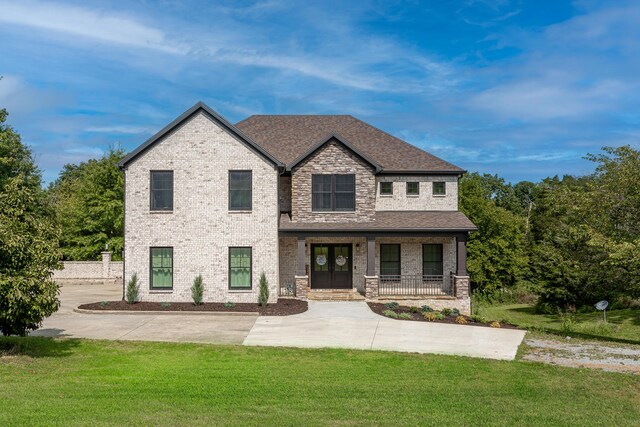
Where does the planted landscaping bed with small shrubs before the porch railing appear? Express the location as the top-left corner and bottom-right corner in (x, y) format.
(367, 302), (519, 329)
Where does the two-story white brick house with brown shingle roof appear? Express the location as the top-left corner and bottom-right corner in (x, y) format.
(120, 103), (476, 313)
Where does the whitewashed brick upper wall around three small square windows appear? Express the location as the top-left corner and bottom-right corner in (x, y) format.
(376, 175), (458, 211)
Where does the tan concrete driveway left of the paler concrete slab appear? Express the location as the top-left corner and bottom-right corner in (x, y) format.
(31, 285), (258, 344)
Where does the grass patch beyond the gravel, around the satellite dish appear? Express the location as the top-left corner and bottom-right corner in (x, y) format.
(474, 304), (640, 344)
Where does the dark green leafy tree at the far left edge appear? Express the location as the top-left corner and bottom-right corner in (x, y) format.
(0, 109), (60, 336)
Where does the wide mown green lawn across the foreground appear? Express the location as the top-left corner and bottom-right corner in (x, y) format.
(0, 338), (640, 426)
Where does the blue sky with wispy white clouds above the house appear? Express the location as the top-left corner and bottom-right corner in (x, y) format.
(0, 0), (640, 181)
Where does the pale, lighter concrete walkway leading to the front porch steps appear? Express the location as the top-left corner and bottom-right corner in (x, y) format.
(244, 301), (525, 360)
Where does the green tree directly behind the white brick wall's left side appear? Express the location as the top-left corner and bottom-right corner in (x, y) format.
(49, 147), (125, 261)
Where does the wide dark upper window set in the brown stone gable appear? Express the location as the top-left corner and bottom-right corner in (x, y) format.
(311, 174), (356, 211)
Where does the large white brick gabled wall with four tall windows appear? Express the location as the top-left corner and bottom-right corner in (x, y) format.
(125, 113), (279, 302)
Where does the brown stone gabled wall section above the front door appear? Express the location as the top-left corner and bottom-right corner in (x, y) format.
(291, 140), (376, 222)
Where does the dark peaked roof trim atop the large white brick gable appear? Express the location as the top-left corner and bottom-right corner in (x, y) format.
(118, 102), (284, 168)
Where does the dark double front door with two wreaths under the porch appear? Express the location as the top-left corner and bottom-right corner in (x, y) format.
(311, 243), (352, 289)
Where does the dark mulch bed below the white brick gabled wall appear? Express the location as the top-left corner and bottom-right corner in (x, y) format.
(78, 298), (308, 316)
